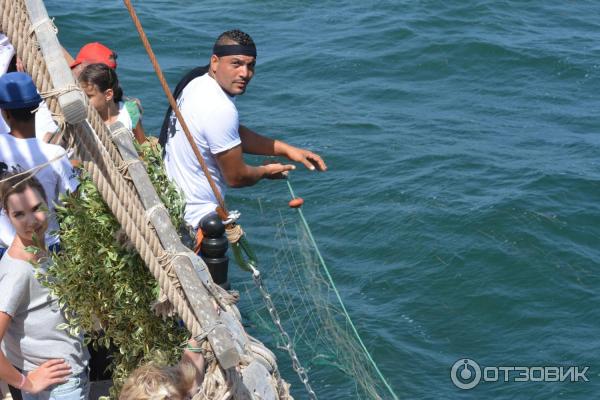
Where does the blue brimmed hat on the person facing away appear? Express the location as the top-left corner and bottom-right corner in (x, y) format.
(0, 72), (42, 110)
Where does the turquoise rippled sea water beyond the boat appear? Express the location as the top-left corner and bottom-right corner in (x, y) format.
(47, 0), (600, 399)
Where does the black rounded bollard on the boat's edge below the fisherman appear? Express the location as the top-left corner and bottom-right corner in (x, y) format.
(200, 213), (229, 289)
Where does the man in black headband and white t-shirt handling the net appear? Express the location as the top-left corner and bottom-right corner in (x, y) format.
(159, 30), (327, 241)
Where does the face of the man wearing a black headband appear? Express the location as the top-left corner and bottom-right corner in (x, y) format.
(210, 54), (256, 96)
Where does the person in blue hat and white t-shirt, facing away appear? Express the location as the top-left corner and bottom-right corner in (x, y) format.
(0, 72), (79, 256)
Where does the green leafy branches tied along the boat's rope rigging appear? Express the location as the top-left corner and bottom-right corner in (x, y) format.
(38, 143), (187, 398)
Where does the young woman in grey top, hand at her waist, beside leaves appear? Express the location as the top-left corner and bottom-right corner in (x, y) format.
(0, 173), (89, 400)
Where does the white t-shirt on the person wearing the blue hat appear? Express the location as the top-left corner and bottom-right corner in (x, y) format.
(0, 135), (79, 247)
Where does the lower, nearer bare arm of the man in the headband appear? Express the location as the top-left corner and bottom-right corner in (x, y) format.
(216, 145), (295, 187)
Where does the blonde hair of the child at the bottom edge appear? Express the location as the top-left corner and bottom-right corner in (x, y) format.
(119, 360), (196, 400)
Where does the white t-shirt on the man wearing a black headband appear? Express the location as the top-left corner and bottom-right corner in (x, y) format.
(165, 74), (241, 228)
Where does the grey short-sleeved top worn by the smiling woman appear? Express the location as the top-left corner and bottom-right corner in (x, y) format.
(0, 253), (89, 374)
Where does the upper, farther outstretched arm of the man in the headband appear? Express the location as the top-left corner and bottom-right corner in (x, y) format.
(239, 124), (327, 171)
